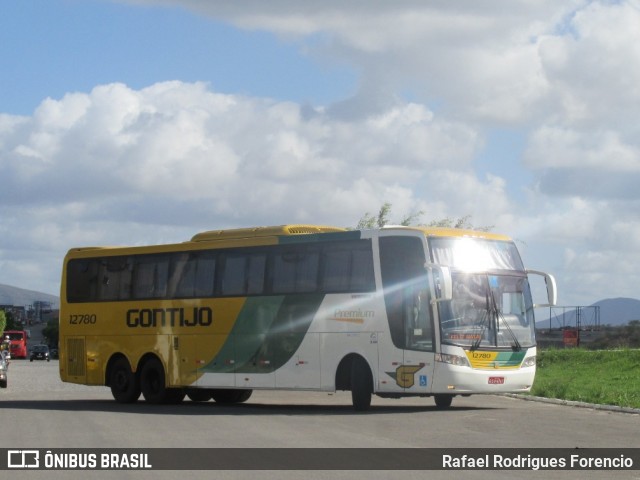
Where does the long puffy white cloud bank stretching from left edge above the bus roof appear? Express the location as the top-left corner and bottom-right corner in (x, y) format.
(0, 81), (488, 291)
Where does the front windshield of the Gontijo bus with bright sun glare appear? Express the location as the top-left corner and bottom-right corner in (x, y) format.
(431, 238), (535, 350)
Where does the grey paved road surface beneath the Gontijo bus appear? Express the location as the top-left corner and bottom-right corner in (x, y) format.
(0, 360), (640, 480)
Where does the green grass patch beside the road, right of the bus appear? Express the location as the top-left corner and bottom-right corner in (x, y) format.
(531, 349), (640, 408)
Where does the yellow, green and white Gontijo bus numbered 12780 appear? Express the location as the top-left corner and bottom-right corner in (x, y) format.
(60, 225), (556, 410)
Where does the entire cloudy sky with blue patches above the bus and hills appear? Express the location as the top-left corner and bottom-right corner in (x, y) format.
(0, 0), (640, 305)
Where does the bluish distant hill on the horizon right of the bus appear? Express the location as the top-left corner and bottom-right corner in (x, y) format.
(536, 298), (640, 329)
